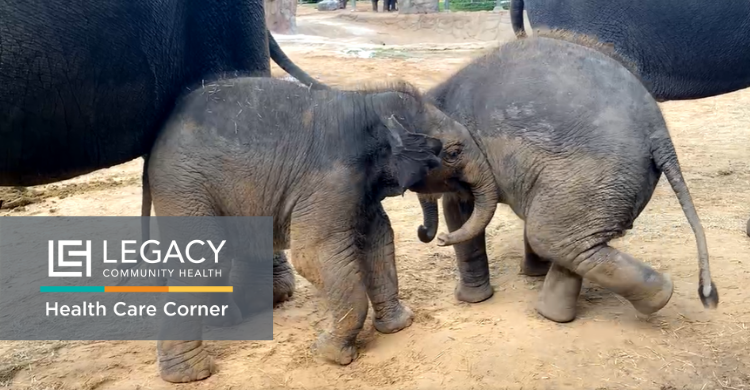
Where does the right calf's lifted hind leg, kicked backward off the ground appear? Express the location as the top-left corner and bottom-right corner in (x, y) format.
(571, 244), (674, 314)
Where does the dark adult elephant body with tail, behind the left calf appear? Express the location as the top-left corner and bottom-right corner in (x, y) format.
(0, 0), (324, 186)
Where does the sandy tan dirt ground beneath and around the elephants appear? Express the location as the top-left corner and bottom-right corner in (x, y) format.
(0, 5), (750, 390)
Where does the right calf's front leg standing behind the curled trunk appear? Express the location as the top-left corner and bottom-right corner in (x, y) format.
(443, 194), (494, 303)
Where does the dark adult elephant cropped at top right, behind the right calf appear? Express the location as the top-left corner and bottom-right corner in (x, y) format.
(510, 0), (750, 236)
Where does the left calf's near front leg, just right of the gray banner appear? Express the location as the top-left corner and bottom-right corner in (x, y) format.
(291, 218), (368, 365)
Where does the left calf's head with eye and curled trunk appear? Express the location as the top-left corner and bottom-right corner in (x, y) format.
(396, 104), (498, 246)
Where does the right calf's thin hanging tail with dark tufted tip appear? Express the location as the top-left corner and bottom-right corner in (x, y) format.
(651, 129), (719, 309)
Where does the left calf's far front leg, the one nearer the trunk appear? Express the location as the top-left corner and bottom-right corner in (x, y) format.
(363, 203), (414, 333)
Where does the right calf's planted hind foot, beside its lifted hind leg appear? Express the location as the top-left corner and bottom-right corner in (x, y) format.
(536, 264), (583, 323)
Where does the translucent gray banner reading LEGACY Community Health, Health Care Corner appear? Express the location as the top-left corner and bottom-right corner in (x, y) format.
(0, 217), (273, 340)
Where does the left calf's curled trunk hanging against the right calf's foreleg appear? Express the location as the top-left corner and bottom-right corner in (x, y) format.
(438, 151), (499, 246)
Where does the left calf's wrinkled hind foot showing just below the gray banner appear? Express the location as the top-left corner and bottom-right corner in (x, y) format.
(159, 341), (216, 383)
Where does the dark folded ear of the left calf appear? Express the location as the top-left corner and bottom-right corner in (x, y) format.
(383, 115), (443, 193)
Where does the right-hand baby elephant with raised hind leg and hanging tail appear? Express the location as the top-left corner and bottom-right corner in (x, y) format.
(419, 36), (719, 322)
